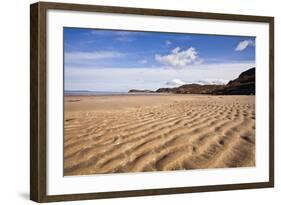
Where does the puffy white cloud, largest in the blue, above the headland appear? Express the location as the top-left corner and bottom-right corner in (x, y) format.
(155, 47), (202, 69)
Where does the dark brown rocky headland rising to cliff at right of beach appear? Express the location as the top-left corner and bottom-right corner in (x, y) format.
(156, 68), (256, 95)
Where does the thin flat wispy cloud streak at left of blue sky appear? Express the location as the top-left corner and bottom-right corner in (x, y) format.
(65, 51), (126, 63)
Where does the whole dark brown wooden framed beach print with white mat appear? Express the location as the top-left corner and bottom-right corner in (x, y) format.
(30, 2), (274, 202)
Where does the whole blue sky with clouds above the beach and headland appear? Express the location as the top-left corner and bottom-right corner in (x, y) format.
(64, 28), (255, 92)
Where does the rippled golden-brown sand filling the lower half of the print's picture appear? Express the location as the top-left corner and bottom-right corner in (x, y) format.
(64, 95), (255, 175)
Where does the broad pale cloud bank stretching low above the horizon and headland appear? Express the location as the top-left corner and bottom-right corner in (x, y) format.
(65, 62), (255, 92)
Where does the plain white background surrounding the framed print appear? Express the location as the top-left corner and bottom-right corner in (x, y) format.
(0, 0), (281, 205)
